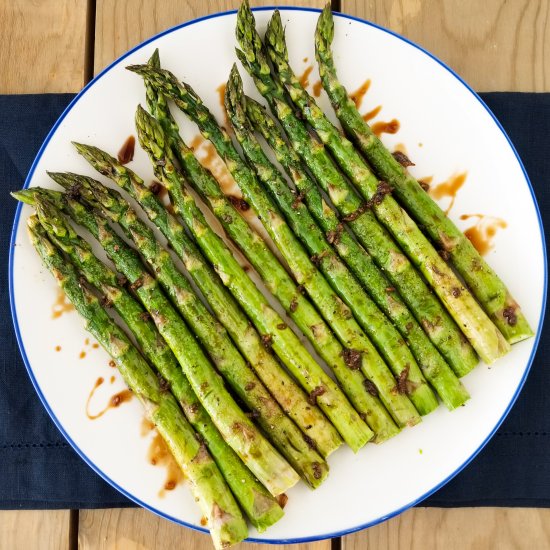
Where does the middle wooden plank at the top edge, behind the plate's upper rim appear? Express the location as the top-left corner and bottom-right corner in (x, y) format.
(95, 0), (324, 74)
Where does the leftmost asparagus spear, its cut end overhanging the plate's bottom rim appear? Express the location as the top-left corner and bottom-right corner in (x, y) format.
(23, 216), (247, 548)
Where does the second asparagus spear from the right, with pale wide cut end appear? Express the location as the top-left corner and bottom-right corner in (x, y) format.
(266, 11), (510, 364)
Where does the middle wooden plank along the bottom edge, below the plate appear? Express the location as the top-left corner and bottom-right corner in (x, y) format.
(78, 508), (330, 550)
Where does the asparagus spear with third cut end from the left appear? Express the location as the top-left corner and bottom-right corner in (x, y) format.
(38, 183), (298, 495)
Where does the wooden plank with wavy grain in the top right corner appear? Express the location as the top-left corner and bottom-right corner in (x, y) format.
(341, 0), (550, 92)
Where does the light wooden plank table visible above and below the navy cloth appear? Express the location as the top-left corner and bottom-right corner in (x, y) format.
(0, 0), (550, 550)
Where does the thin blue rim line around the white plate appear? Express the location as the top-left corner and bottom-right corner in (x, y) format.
(8, 6), (548, 544)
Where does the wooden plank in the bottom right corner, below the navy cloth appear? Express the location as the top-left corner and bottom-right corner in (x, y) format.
(342, 508), (550, 550)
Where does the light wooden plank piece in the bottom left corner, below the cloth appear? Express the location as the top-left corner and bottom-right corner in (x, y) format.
(0, 510), (70, 550)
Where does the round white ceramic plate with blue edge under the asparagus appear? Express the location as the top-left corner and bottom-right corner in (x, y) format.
(10, 8), (546, 542)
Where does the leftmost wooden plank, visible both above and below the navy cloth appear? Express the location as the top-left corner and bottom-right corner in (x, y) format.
(0, 0), (88, 550)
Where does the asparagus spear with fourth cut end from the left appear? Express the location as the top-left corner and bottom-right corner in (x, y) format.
(50, 174), (328, 487)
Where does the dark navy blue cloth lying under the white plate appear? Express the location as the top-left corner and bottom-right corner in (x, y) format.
(0, 93), (550, 509)
